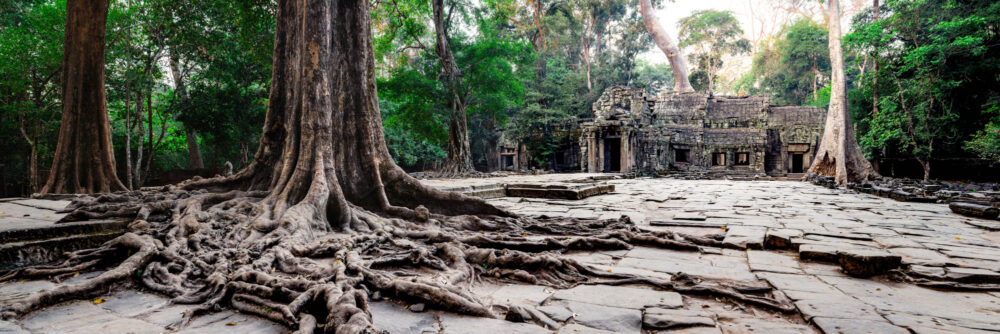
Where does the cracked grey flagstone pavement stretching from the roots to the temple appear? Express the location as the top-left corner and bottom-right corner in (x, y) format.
(0, 174), (1000, 334)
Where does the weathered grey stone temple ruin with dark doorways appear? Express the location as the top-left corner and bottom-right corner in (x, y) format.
(497, 86), (826, 176)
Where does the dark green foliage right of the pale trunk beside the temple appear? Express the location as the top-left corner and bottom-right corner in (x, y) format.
(845, 0), (1000, 166)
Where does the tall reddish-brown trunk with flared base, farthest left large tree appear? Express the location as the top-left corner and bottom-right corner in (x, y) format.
(41, 0), (125, 194)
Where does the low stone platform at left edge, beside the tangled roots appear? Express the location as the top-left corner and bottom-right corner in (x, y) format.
(0, 198), (127, 271)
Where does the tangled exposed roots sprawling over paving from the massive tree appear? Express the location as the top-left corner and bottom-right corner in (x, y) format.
(2, 187), (794, 333)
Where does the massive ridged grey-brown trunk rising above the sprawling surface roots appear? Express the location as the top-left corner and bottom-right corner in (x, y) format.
(180, 0), (503, 224)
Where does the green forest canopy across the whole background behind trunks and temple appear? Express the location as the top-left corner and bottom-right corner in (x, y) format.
(0, 0), (1000, 195)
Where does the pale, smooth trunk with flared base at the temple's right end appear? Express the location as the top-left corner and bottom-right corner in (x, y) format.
(809, 0), (878, 186)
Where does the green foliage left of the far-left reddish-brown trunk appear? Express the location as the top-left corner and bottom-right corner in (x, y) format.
(0, 0), (66, 196)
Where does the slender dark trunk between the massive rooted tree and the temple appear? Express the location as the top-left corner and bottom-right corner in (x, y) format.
(431, 0), (476, 176)
